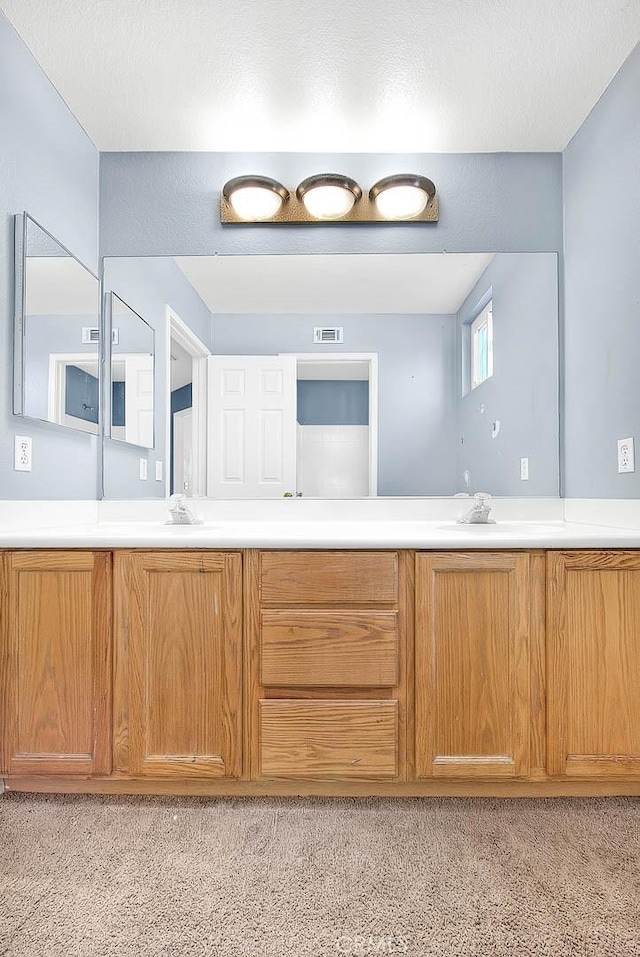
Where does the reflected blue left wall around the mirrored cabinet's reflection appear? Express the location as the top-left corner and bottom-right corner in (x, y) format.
(104, 258), (211, 498)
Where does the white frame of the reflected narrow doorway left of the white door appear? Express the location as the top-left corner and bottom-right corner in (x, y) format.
(165, 306), (211, 498)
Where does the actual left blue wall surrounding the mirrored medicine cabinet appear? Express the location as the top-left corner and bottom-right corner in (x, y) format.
(0, 14), (99, 499)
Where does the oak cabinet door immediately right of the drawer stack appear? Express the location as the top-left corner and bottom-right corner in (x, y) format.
(415, 552), (531, 778)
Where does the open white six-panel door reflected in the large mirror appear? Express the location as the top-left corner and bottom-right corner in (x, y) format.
(207, 356), (296, 498)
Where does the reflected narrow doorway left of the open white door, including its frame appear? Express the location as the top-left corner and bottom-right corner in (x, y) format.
(166, 306), (210, 496)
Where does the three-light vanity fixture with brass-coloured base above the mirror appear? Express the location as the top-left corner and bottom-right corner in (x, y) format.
(220, 173), (439, 225)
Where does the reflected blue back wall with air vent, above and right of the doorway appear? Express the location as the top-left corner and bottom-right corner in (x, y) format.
(211, 315), (456, 495)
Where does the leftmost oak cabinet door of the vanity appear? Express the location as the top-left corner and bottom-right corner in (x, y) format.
(0, 551), (111, 776)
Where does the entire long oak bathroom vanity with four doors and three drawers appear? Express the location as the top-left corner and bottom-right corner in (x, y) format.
(0, 512), (640, 796)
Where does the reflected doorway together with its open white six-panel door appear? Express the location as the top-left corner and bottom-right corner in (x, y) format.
(207, 353), (378, 498)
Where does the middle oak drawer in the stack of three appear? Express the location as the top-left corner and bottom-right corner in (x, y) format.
(260, 609), (398, 688)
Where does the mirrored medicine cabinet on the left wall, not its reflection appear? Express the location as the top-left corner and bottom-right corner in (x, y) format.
(14, 213), (100, 434)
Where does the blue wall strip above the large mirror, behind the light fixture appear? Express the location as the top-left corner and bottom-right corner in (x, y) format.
(100, 153), (562, 256)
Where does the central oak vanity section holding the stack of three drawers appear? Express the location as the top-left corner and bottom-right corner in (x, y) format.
(245, 551), (411, 782)
